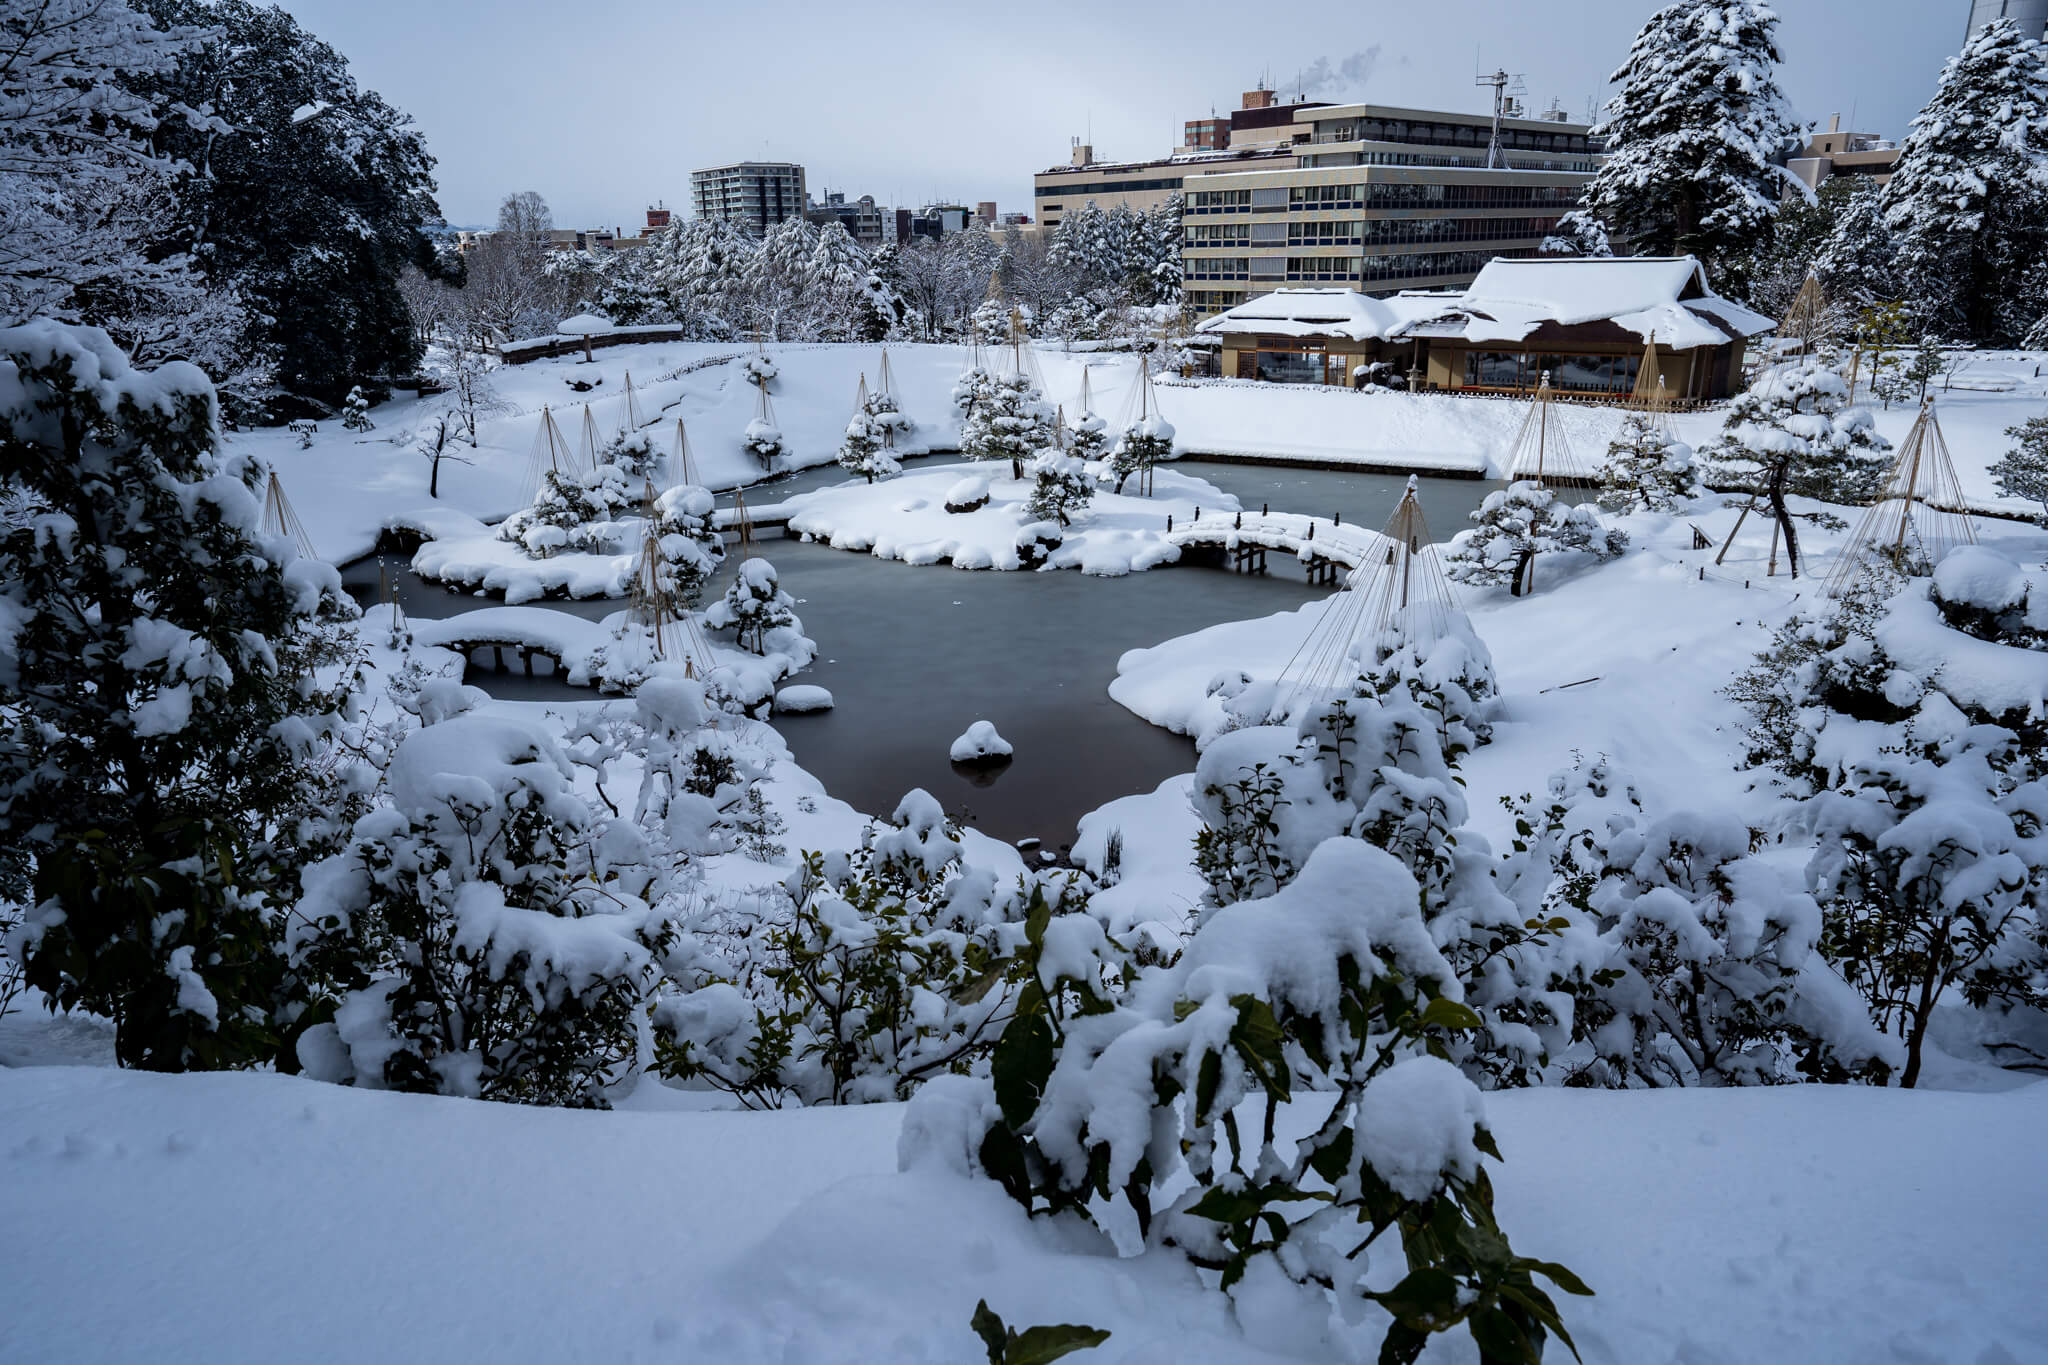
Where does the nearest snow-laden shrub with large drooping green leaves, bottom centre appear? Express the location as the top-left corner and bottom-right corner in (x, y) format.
(925, 837), (1585, 1361)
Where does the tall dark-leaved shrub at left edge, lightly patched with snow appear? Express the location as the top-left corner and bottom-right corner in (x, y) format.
(0, 321), (360, 1070)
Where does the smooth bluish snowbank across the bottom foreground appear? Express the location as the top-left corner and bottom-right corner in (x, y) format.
(0, 1066), (2048, 1365)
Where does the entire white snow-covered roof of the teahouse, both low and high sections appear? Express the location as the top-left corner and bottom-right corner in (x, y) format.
(1196, 256), (1778, 350)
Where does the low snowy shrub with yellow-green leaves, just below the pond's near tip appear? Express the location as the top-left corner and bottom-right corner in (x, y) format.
(655, 792), (1069, 1107)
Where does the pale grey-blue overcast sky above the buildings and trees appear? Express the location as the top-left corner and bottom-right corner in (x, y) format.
(283, 0), (1970, 227)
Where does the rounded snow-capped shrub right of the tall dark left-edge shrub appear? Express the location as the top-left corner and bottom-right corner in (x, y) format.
(291, 714), (674, 1107)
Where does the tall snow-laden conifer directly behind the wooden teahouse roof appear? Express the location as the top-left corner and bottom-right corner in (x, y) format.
(1569, 0), (1804, 276)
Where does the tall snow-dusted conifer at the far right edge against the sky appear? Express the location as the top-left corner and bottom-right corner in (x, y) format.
(1884, 18), (2048, 342)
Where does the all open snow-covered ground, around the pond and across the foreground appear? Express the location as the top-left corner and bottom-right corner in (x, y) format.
(0, 344), (2048, 1365)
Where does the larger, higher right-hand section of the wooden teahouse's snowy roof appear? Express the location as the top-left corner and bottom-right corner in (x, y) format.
(1458, 256), (1776, 350)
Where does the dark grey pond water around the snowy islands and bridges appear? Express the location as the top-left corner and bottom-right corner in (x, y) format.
(331, 456), (1493, 847)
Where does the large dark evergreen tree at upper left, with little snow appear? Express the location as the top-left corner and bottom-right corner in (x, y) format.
(137, 0), (442, 409)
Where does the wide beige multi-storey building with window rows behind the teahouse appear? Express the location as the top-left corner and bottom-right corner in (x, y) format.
(1182, 104), (1599, 317)
